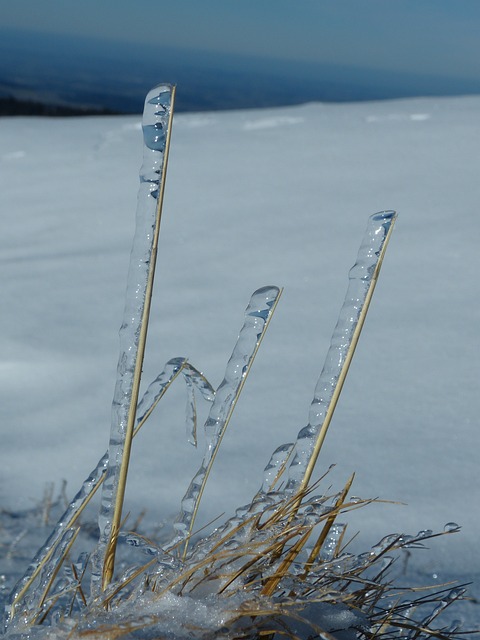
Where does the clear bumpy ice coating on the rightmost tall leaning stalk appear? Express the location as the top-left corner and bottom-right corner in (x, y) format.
(287, 211), (396, 492)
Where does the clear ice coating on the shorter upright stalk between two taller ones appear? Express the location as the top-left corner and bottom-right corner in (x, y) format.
(174, 286), (281, 544)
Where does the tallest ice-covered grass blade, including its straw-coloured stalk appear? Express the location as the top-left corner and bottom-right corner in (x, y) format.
(92, 85), (175, 593)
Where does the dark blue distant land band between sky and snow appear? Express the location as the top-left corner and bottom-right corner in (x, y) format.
(0, 29), (480, 115)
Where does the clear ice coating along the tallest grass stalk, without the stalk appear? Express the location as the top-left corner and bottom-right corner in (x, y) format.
(92, 84), (173, 593)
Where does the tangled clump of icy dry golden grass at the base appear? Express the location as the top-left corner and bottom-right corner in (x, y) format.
(0, 478), (470, 640)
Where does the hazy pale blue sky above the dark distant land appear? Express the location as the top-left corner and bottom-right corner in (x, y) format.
(0, 0), (480, 78)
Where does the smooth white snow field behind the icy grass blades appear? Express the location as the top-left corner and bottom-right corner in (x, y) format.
(0, 97), (480, 617)
